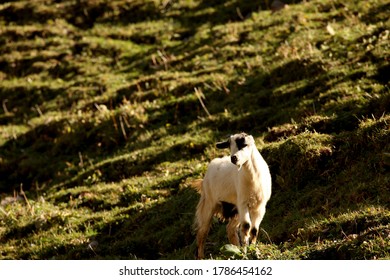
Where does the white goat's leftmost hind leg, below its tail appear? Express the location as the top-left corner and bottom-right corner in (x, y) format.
(196, 197), (215, 259)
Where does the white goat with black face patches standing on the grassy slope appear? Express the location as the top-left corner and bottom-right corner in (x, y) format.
(195, 133), (271, 259)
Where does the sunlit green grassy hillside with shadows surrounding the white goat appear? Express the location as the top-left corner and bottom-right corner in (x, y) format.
(0, 0), (390, 259)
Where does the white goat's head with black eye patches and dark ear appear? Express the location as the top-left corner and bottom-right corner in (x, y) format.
(217, 133), (255, 168)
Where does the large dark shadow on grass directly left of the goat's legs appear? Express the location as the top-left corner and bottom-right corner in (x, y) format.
(11, 189), (198, 259)
